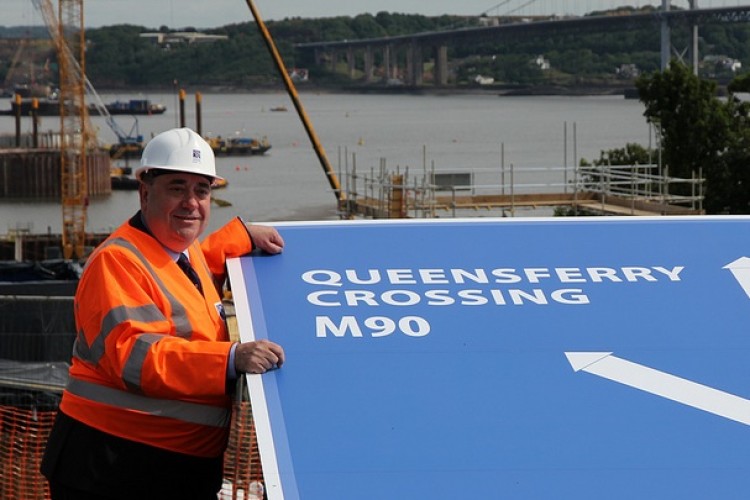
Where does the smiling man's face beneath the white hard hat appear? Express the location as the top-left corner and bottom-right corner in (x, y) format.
(139, 172), (211, 252)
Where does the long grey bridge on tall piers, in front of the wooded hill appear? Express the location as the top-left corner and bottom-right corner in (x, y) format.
(295, 0), (750, 87)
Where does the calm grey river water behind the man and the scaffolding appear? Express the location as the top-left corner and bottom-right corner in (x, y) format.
(0, 91), (652, 233)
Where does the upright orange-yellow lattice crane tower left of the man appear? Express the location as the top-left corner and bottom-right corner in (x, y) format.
(32, 0), (91, 259)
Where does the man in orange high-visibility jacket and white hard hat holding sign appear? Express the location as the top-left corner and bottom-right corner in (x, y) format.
(42, 128), (284, 500)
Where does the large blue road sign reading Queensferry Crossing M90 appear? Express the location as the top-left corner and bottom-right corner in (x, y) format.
(229, 217), (750, 500)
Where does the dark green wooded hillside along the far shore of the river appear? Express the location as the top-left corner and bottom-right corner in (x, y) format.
(0, 8), (750, 90)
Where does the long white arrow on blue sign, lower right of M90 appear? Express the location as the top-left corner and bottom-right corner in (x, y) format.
(565, 352), (750, 425)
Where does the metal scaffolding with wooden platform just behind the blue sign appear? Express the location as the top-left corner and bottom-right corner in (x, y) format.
(341, 159), (705, 219)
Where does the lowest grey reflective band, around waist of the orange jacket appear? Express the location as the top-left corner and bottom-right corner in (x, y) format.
(66, 378), (231, 427)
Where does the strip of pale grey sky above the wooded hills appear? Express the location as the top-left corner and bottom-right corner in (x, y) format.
(0, 0), (712, 29)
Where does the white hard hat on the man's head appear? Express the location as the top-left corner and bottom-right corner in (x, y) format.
(135, 127), (223, 182)
